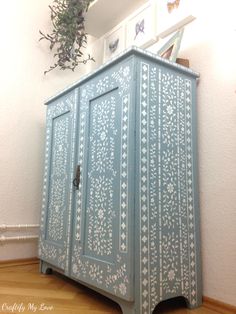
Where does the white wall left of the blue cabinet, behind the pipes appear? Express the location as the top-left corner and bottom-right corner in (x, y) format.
(0, 0), (90, 260)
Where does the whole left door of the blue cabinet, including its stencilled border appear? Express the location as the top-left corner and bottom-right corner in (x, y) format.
(39, 89), (78, 273)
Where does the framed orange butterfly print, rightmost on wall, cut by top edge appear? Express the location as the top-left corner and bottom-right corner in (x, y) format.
(157, 0), (196, 38)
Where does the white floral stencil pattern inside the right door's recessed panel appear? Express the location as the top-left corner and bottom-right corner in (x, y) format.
(86, 97), (118, 258)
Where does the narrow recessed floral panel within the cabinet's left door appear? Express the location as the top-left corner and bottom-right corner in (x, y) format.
(45, 111), (70, 245)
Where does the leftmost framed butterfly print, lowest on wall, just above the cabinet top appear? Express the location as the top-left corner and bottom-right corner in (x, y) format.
(103, 24), (125, 62)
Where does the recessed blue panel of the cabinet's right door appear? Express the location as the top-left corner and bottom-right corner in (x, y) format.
(84, 89), (121, 263)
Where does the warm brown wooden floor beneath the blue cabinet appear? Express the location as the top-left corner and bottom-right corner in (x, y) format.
(0, 263), (230, 314)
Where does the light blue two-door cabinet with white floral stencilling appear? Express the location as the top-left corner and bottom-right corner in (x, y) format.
(39, 48), (201, 314)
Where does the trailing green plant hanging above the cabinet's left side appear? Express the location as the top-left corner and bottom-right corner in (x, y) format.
(39, 0), (94, 74)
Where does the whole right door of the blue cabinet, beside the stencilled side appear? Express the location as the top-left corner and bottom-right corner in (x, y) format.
(71, 59), (134, 300)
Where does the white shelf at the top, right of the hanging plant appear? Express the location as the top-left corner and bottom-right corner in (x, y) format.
(85, 0), (148, 38)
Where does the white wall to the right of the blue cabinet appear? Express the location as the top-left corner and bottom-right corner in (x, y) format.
(180, 0), (236, 305)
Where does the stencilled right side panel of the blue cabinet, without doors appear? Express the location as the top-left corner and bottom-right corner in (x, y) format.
(136, 60), (201, 313)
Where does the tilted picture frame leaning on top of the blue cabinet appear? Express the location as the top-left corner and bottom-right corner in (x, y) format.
(157, 29), (184, 62)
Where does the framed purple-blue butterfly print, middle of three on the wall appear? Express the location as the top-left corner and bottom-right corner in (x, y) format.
(126, 2), (156, 48)
